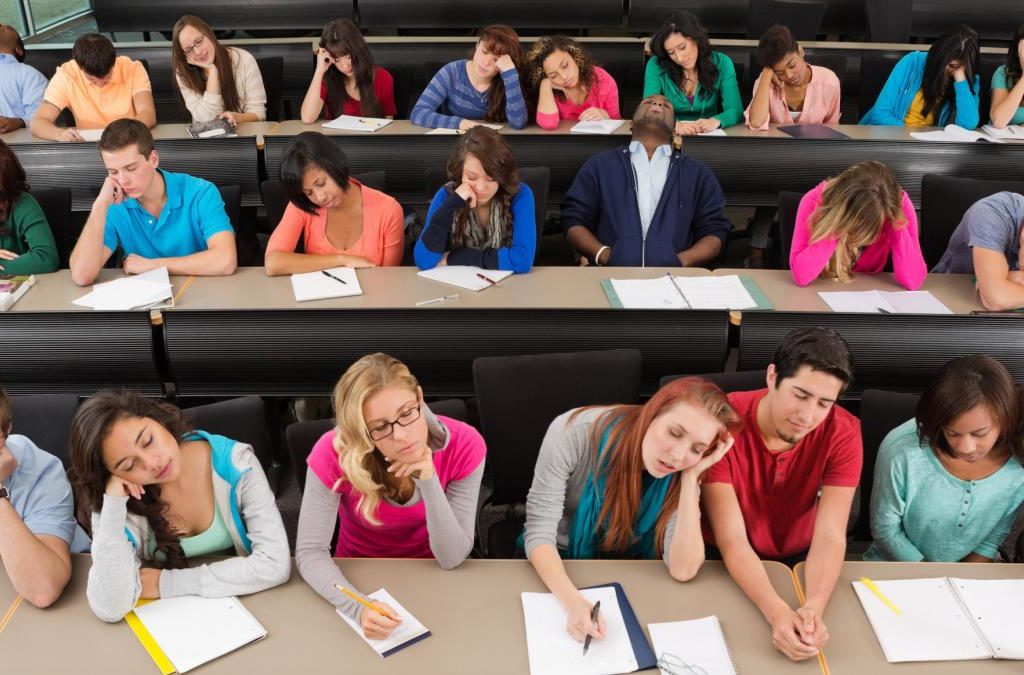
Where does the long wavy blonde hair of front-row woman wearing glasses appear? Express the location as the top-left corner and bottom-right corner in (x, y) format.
(333, 352), (420, 525)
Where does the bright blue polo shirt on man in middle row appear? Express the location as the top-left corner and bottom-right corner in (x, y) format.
(103, 171), (233, 258)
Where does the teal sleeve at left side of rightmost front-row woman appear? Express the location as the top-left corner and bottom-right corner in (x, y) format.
(871, 427), (925, 562)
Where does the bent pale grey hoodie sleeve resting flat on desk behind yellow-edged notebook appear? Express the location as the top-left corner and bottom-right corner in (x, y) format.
(160, 448), (292, 597)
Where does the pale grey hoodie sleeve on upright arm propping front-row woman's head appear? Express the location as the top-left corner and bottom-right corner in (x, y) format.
(85, 495), (144, 624)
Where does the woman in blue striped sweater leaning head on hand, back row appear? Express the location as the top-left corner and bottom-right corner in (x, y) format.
(411, 25), (528, 131)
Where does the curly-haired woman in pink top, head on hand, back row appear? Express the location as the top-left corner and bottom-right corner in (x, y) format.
(526, 35), (622, 129)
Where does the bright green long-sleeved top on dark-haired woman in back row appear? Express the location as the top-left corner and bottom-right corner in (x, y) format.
(643, 51), (743, 129)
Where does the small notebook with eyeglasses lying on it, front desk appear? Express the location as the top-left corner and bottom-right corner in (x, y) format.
(647, 615), (736, 675)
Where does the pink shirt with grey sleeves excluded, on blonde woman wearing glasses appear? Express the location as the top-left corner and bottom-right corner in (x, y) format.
(306, 416), (486, 558)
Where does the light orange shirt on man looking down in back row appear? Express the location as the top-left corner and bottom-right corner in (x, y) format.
(43, 56), (153, 129)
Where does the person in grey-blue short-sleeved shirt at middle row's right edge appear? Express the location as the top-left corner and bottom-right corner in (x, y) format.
(933, 193), (1024, 311)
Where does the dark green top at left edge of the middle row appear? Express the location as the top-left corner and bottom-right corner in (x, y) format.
(0, 193), (58, 275)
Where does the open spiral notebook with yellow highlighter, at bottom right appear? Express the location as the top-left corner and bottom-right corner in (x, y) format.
(853, 577), (1024, 663)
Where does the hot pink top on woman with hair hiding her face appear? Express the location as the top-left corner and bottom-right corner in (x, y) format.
(790, 181), (928, 291)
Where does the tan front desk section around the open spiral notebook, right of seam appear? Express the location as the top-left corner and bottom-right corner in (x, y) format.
(796, 561), (1024, 675)
